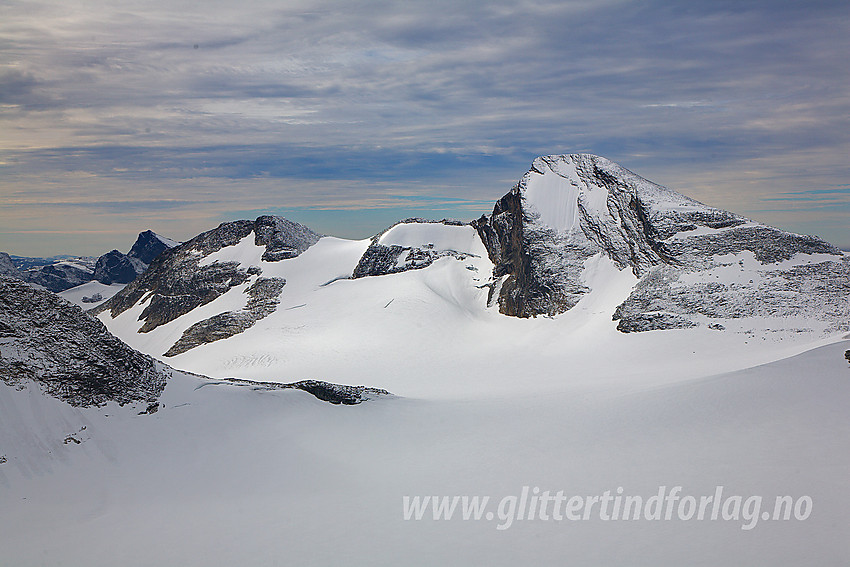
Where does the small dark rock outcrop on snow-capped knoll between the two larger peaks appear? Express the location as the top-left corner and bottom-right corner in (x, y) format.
(351, 218), (470, 279)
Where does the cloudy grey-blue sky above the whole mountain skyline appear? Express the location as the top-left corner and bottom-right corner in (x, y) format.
(0, 0), (850, 255)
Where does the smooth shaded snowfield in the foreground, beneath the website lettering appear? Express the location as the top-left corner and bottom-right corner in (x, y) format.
(0, 342), (850, 567)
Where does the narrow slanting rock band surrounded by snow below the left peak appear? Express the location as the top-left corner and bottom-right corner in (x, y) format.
(164, 278), (286, 356)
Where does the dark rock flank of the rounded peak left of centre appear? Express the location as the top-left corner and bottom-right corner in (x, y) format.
(95, 217), (319, 336)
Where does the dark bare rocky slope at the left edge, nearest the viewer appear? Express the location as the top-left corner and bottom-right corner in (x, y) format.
(0, 276), (167, 406)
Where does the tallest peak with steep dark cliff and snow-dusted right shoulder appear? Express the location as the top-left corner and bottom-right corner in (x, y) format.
(473, 154), (850, 332)
